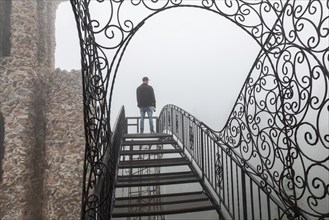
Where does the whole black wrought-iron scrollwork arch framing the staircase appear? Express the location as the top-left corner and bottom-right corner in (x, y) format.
(70, 0), (329, 219)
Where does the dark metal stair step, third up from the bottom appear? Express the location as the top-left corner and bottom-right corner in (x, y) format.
(119, 158), (190, 169)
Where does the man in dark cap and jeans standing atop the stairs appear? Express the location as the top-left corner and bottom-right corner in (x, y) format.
(136, 76), (155, 133)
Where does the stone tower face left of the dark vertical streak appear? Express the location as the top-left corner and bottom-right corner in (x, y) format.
(0, 1), (37, 219)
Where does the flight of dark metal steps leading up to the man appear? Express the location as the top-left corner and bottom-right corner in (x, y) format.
(112, 133), (216, 219)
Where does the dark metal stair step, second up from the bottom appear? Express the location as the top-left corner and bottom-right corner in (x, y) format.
(116, 172), (201, 187)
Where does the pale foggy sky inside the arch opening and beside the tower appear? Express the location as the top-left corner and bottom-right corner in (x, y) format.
(55, 2), (260, 130)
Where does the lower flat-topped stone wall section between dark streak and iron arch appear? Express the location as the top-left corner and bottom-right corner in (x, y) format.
(44, 70), (85, 219)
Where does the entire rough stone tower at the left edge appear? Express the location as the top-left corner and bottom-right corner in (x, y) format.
(0, 0), (84, 220)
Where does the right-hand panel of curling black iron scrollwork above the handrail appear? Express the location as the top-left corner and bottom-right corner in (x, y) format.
(215, 1), (329, 218)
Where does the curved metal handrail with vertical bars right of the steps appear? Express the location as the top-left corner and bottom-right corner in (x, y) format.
(159, 105), (304, 219)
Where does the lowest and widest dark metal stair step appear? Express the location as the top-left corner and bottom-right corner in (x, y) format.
(112, 192), (215, 217)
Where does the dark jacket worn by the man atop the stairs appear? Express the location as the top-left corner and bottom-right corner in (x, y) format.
(136, 83), (155, 107)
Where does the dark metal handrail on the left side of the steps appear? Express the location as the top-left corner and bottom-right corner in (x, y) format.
(82, 107), (126, 219)
